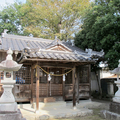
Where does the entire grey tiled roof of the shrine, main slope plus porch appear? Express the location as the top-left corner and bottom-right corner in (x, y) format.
(0, 33), (103, 61)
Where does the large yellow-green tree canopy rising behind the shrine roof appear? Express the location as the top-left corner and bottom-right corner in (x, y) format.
(0, 0), (90, 40)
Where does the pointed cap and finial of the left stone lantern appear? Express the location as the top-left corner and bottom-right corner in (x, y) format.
(0, 48), (22, 71)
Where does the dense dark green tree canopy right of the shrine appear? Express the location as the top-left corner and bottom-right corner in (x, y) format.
(75, 0), (120, 69)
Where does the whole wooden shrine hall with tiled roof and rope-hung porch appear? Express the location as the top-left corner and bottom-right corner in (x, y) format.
(0, 32), (104, 109)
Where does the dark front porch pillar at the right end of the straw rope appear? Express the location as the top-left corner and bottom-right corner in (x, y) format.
(72, 67), (76, 109)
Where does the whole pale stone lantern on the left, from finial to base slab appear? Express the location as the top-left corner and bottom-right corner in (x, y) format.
(0, 48), (25, 120)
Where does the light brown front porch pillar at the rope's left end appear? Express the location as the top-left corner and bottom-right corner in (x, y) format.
(36, 66), (39, 112)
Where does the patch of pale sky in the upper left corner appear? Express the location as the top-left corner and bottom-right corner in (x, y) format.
(0, 0), (26, 10)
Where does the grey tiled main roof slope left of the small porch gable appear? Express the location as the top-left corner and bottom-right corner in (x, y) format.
(0, 34), (53, 51)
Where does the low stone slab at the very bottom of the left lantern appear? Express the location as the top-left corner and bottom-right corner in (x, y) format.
(0, 109), (26, 120)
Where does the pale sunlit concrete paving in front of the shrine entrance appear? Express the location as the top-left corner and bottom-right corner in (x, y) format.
(18, 100), (108, 120)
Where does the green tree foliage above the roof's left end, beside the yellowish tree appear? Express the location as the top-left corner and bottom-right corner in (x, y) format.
(0, 3), (21, 34)
